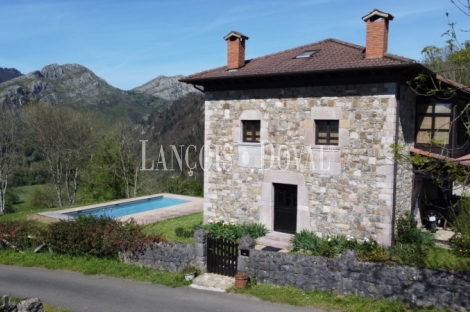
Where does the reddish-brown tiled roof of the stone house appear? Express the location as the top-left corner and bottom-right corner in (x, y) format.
(181, 39), (416, 82)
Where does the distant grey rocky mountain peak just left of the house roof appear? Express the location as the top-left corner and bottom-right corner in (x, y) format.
(132, 76), (200, 101)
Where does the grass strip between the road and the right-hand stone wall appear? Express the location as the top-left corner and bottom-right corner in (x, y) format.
(229, 284), (450, 312)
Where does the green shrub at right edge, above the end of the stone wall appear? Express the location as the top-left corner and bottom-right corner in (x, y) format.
(450, 198), (470, 257)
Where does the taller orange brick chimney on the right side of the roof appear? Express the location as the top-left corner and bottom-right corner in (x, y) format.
(362, 9), (393, 58)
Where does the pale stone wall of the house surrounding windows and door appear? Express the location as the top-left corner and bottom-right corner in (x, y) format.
(204, 83), (414, 245)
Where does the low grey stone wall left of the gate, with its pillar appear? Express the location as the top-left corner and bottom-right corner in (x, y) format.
(120, 230), (207, 272)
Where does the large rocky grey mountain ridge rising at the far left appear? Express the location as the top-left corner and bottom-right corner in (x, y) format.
(0, 64), (168, 122)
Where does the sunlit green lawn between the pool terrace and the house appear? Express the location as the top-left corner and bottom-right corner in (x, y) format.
(144, 212), (203, 244)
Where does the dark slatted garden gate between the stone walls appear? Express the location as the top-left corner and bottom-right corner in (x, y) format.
(207, 236), (238, 276)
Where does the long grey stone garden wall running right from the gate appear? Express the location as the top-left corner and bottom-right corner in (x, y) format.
(238, 239), (470, 311)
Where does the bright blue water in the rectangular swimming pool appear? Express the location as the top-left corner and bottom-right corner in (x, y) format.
(64, 196), (189, 218)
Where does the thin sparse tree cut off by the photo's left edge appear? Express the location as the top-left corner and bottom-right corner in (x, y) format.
(0, 109), (21, 215)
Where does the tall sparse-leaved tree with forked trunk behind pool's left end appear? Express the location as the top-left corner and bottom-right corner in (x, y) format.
(22, 103), (99, 207)
